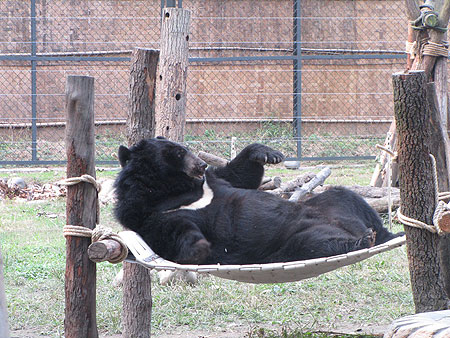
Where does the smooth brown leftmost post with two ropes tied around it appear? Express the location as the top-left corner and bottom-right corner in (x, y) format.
(64, 76), (98, 338)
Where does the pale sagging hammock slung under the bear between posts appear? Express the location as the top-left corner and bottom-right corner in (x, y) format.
(119, 231), (406, 283)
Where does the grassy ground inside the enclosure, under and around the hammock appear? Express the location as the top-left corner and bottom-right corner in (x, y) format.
(0, 162), (414, 338)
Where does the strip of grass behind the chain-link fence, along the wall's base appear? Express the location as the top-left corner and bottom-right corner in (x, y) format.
(0, 121), (385, 165)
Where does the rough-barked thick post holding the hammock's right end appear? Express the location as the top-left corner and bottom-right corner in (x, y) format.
(392, 71), (447, 312)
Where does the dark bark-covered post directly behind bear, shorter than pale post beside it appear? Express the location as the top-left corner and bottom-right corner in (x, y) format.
(122, 48), (159, 338)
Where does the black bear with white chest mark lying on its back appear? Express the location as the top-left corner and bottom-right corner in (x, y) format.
(115, 137), (398, 264)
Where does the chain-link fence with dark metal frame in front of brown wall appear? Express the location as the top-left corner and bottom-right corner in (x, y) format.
(0, 0), (408, 164)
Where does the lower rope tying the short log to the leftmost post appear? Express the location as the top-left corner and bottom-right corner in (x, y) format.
(63, 225), (128, 264)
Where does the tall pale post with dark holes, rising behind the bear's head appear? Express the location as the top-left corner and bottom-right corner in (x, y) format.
(156, 8), (191, 142)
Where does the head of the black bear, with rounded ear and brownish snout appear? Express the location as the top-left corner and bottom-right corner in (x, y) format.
(118, 136), (207, 178)
